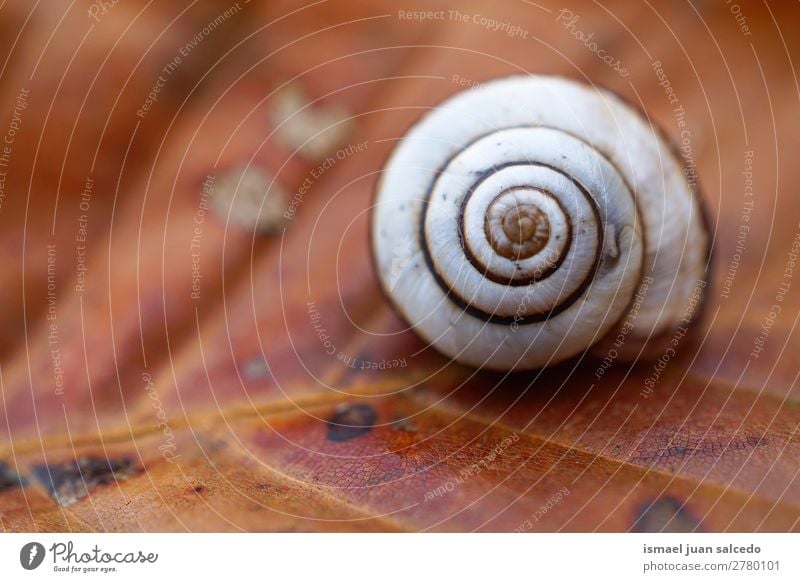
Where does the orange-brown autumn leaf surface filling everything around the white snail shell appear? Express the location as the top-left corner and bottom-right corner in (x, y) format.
(0, 0), (800, 531)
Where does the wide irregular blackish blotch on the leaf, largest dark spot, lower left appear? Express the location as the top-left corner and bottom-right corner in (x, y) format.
(31, 457), (136, 506)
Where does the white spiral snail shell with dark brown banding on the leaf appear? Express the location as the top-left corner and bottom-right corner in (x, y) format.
(371, 76), (711, 370)
